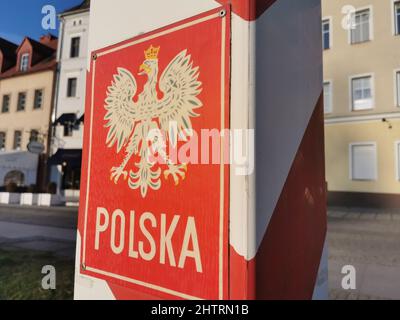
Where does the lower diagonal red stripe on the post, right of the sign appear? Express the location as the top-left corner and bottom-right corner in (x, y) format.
(230, 94), (327, 300)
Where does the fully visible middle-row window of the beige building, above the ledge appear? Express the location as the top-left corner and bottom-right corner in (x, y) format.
(351, 76), (373, 111)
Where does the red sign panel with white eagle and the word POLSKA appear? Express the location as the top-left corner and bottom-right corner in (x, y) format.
(79, 8), (230, 299)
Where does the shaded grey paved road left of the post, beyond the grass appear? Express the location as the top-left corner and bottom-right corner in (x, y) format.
(0, 206), (78, 258)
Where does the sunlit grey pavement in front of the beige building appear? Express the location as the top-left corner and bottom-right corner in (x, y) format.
(328, 208), (400, 299)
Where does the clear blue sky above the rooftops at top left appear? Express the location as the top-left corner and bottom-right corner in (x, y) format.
(0, 0), (82, 44)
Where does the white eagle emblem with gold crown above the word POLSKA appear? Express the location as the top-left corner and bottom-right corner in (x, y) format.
(104, 46), (202, 198)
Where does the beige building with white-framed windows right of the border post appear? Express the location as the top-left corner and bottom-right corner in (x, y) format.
(322, 0), (400, 206)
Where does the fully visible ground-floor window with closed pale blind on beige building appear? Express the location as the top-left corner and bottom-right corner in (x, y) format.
(350, 143), (378, 181)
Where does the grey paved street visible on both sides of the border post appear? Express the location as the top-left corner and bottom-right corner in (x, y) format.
(0, 206), (400, 300)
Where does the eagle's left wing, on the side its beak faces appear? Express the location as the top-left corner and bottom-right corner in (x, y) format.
(104, 68), (137, 152)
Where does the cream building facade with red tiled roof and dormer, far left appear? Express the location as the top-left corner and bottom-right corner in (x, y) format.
(0, 35), (57, 188)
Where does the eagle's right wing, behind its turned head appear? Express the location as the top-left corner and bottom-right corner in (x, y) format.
(156, 50), (203, 146)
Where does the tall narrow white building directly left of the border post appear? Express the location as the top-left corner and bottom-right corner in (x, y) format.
(49, 0), (90, 200)
